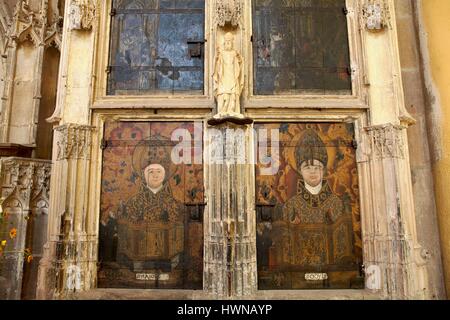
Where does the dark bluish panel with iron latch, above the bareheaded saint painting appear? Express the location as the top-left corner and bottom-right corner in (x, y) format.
(108, 0), (205, 95)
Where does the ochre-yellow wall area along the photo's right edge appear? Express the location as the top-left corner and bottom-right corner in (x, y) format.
(420, 0), (450, 293)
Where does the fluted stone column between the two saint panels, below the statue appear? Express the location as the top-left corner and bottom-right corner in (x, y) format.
(203, 122), (257, 297)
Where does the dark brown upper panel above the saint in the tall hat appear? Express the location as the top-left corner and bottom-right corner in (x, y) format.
(253, 0), (351, 95)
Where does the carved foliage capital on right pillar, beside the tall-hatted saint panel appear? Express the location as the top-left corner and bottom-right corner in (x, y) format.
(365, 124), (405, 159)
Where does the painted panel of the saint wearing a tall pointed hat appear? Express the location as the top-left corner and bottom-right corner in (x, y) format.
(256, 123), (363, 290)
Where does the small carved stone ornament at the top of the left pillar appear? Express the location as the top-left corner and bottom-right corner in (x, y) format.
(68, 0), (96, 30)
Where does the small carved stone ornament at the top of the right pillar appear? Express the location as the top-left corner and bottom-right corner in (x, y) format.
(362, 0), (390, 32)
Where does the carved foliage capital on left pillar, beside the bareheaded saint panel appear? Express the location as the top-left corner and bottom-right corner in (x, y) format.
(55, 124), (94, 161)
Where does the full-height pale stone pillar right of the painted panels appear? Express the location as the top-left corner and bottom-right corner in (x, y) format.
(359, 0), (427, 299)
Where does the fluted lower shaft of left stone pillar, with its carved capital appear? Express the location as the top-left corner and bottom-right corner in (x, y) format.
(38, 124), (97, 299)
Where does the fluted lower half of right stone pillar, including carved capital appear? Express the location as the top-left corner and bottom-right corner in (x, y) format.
(360, 124), (427, 299)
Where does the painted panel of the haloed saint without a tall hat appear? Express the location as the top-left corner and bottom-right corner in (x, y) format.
(98, 122), (203, 289)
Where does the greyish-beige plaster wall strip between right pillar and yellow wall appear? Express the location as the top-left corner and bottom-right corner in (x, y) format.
(395, 0), (445, 299)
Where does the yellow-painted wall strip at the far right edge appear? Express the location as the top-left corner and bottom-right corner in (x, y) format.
(413, 0), (450, 295)
